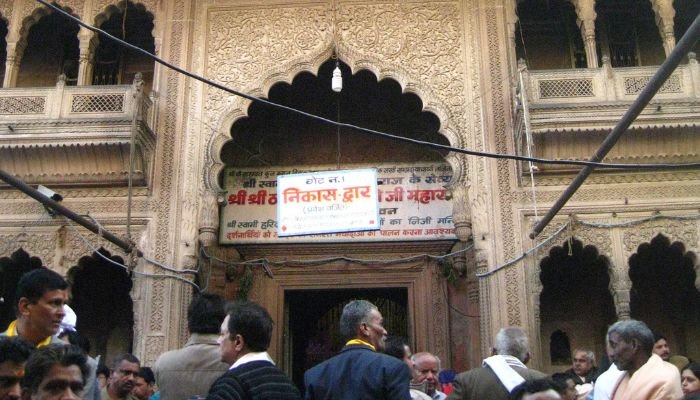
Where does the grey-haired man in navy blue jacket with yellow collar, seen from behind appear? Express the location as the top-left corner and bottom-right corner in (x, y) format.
(304, 300), (411, 400)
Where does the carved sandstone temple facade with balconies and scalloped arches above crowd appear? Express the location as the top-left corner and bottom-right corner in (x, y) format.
(0, 0), (700, 381)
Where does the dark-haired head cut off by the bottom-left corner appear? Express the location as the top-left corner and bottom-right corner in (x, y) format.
(0, 336), (34, 400)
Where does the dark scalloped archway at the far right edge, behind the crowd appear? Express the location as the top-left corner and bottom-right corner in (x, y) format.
(629, 234), (700, 359)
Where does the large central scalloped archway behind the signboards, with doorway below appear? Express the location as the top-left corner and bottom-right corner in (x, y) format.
(220, 59), (456, 374)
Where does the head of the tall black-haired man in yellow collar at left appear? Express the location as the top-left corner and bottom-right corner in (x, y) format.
(15, 268), (68, 345)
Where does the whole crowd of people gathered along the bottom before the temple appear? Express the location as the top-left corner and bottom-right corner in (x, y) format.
(0, 268), (700, 400)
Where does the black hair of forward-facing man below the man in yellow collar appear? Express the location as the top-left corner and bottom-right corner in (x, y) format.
(23, 344), (90, 393)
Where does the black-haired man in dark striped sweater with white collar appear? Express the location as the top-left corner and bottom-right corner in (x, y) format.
(207, 302), (301, 400)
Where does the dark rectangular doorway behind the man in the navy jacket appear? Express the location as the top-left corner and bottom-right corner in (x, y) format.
(284, 288), (409, 388)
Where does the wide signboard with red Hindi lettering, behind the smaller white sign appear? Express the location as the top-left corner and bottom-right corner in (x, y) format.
(219, 162), (457, 244)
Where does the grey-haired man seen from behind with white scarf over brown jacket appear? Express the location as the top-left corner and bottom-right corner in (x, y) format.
(447, 327), (546, 400)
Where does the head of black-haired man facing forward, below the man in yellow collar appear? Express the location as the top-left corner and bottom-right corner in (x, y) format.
(24, 344), (89, 400)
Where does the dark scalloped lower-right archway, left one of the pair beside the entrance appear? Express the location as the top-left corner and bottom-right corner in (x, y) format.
(540, 239), (616, 370)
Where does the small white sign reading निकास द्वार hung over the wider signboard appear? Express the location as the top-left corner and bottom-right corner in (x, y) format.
(277, 169), (379, 237)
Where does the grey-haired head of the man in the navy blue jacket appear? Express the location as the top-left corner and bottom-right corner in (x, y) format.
(340, 300), (387, 351)
